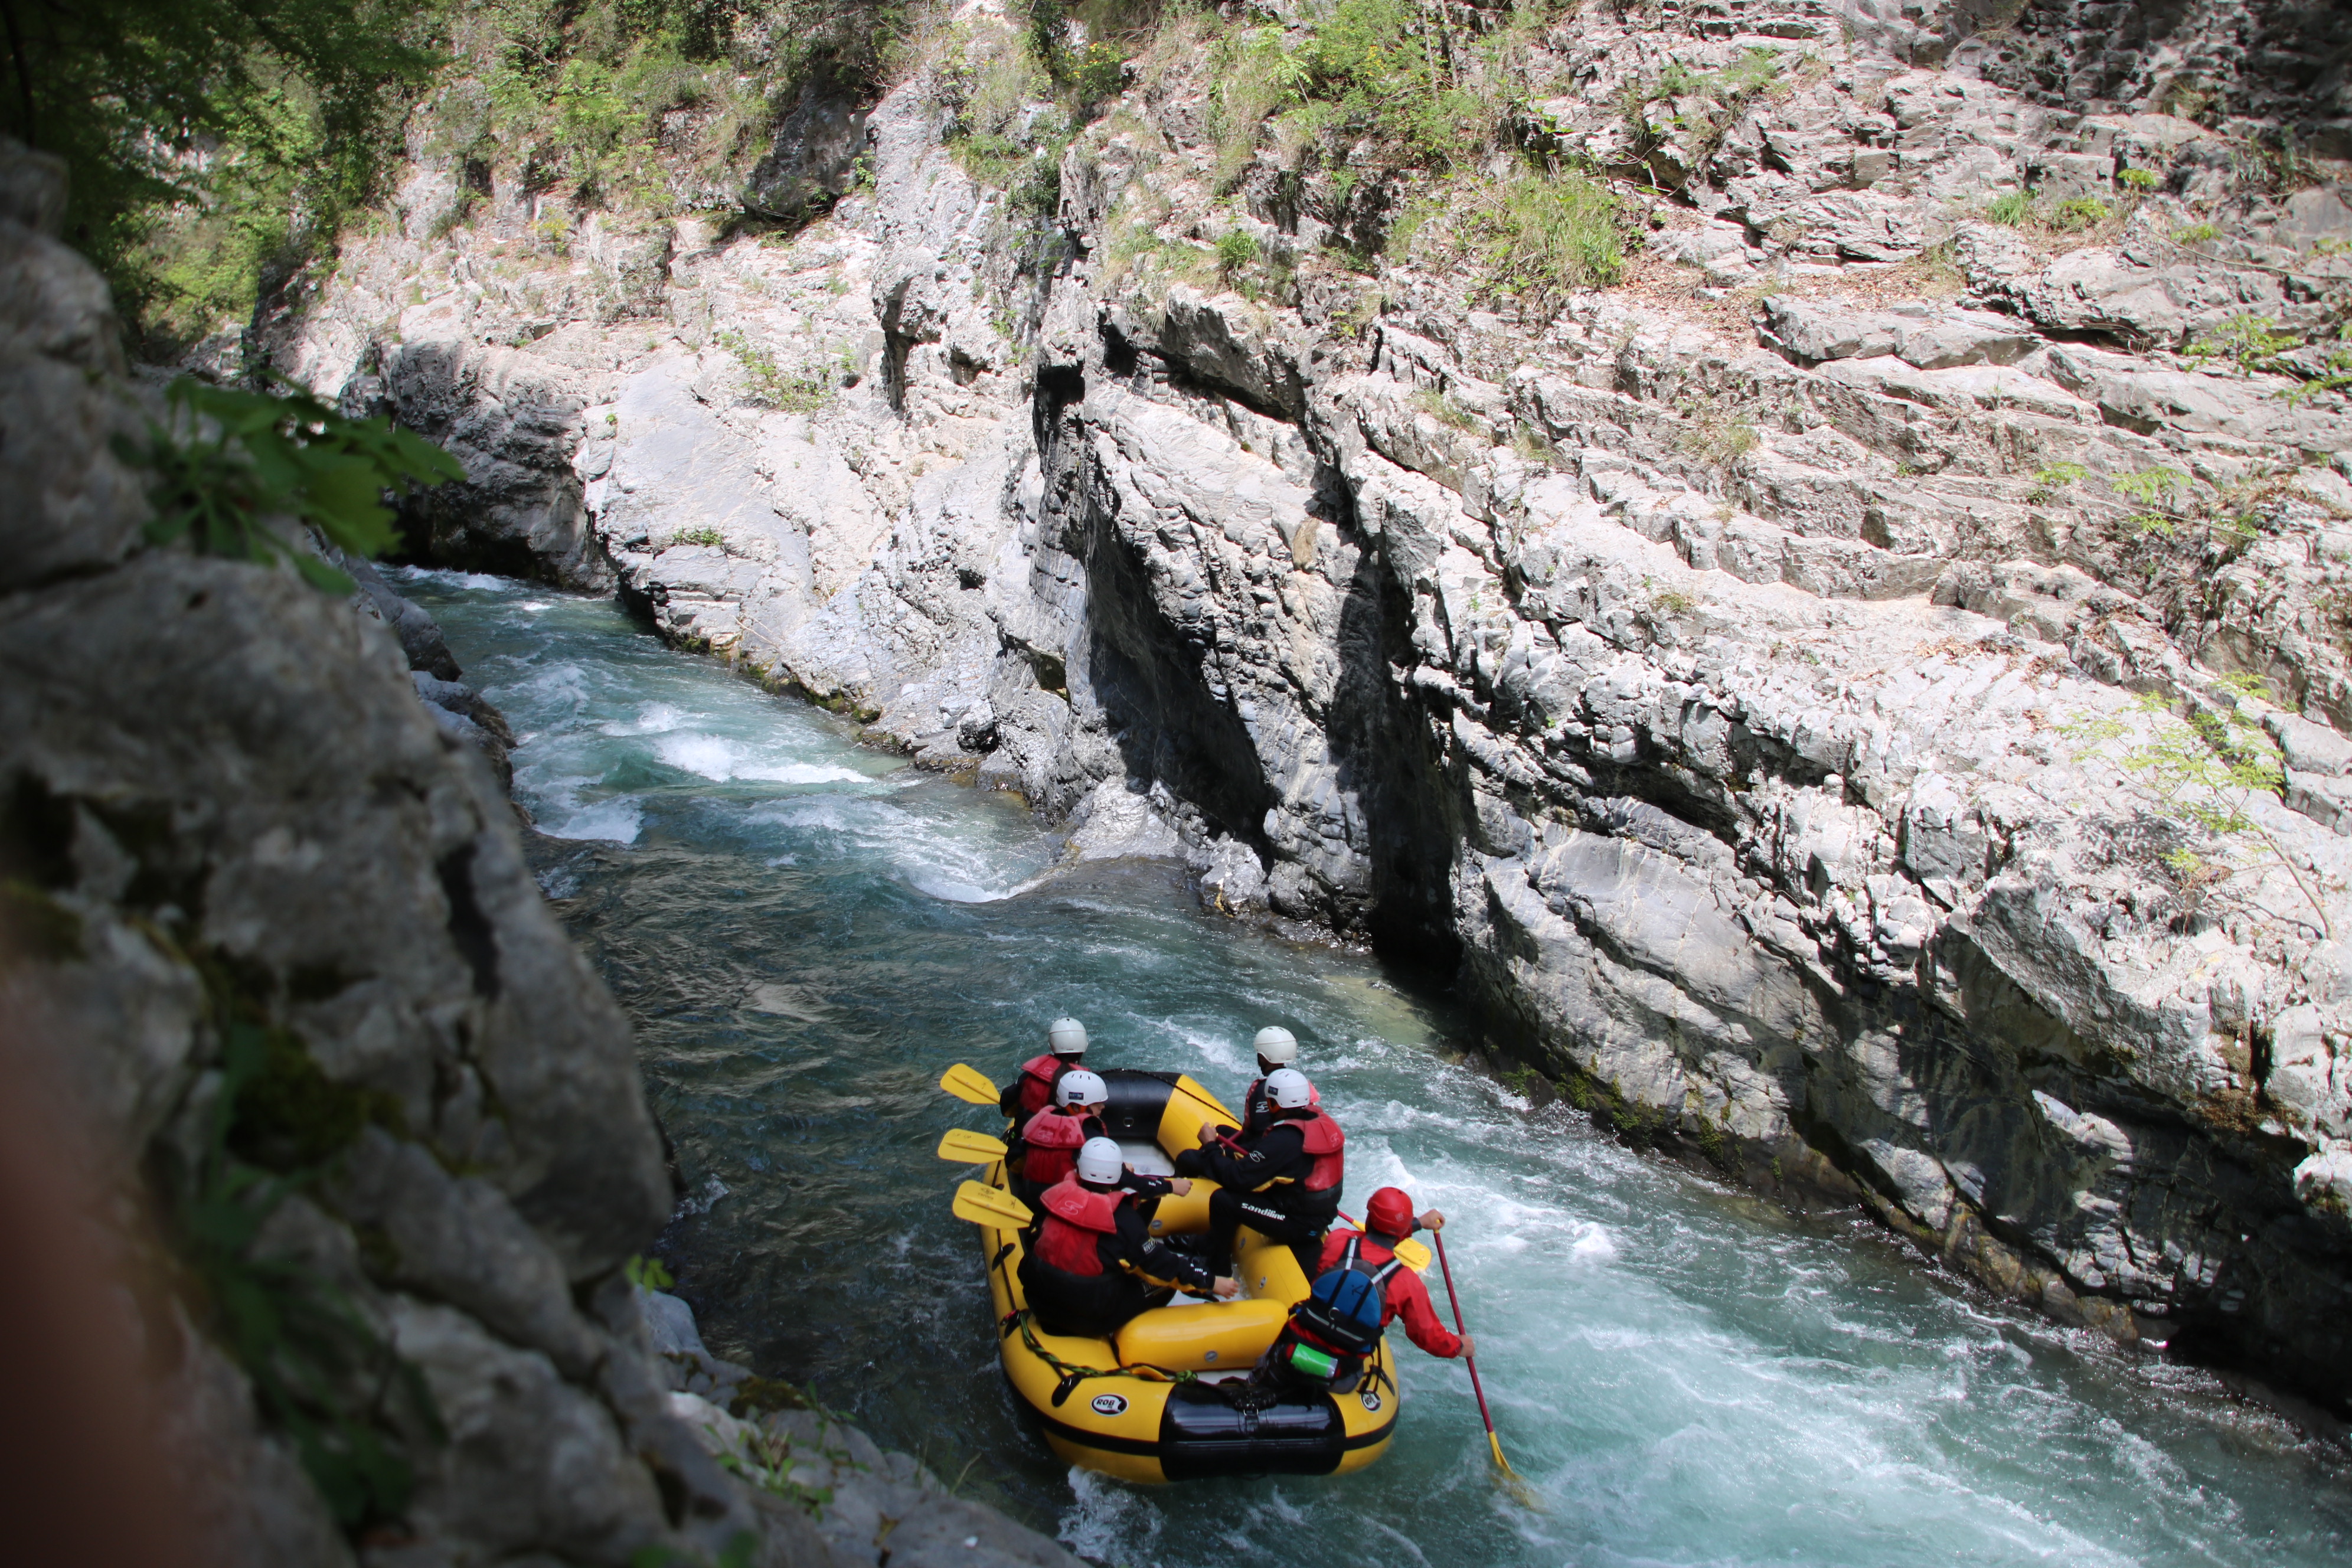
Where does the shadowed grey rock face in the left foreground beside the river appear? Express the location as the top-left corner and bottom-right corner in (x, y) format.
(0, 135), (1070, 1568)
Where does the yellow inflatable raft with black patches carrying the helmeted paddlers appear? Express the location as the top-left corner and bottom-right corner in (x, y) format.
(959, 1067), (1399, 1481)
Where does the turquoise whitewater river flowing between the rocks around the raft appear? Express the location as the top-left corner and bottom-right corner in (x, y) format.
(407, 574), (2352, 1568)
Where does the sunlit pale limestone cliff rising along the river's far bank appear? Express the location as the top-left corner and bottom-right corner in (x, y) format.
(275, 0), (2352, 1403)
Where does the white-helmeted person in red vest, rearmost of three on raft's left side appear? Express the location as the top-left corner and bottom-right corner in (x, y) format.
(1021, 1138), (1242, 1338)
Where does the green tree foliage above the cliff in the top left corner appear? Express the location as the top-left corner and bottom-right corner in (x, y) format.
(0, 0), (908, 352)
